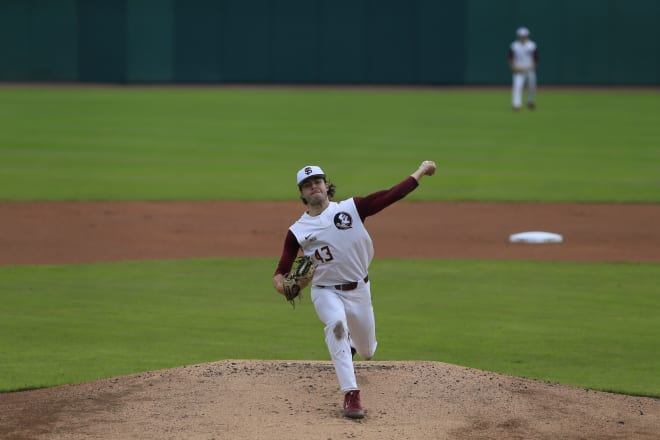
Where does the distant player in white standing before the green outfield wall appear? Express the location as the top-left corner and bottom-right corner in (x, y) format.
(509, 27), (539, 111)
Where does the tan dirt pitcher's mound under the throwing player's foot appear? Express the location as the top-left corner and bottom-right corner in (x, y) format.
(0, 360), (660, 440)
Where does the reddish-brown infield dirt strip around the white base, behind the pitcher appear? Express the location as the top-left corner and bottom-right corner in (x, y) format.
(0, 201), (660, 265)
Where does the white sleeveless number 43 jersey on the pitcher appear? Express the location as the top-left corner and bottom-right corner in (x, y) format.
(289, 198), (374, 286)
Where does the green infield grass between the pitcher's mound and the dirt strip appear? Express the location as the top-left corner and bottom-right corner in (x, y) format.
(0, 258), (660, 397)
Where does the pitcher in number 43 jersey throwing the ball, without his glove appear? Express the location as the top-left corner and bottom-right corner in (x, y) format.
(273, 160), (436, 418)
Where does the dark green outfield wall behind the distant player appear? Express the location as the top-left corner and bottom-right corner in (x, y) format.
(0, 0), (660, 85)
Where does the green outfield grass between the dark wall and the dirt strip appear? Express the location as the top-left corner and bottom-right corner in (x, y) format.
(0, 88), (660, 202)
